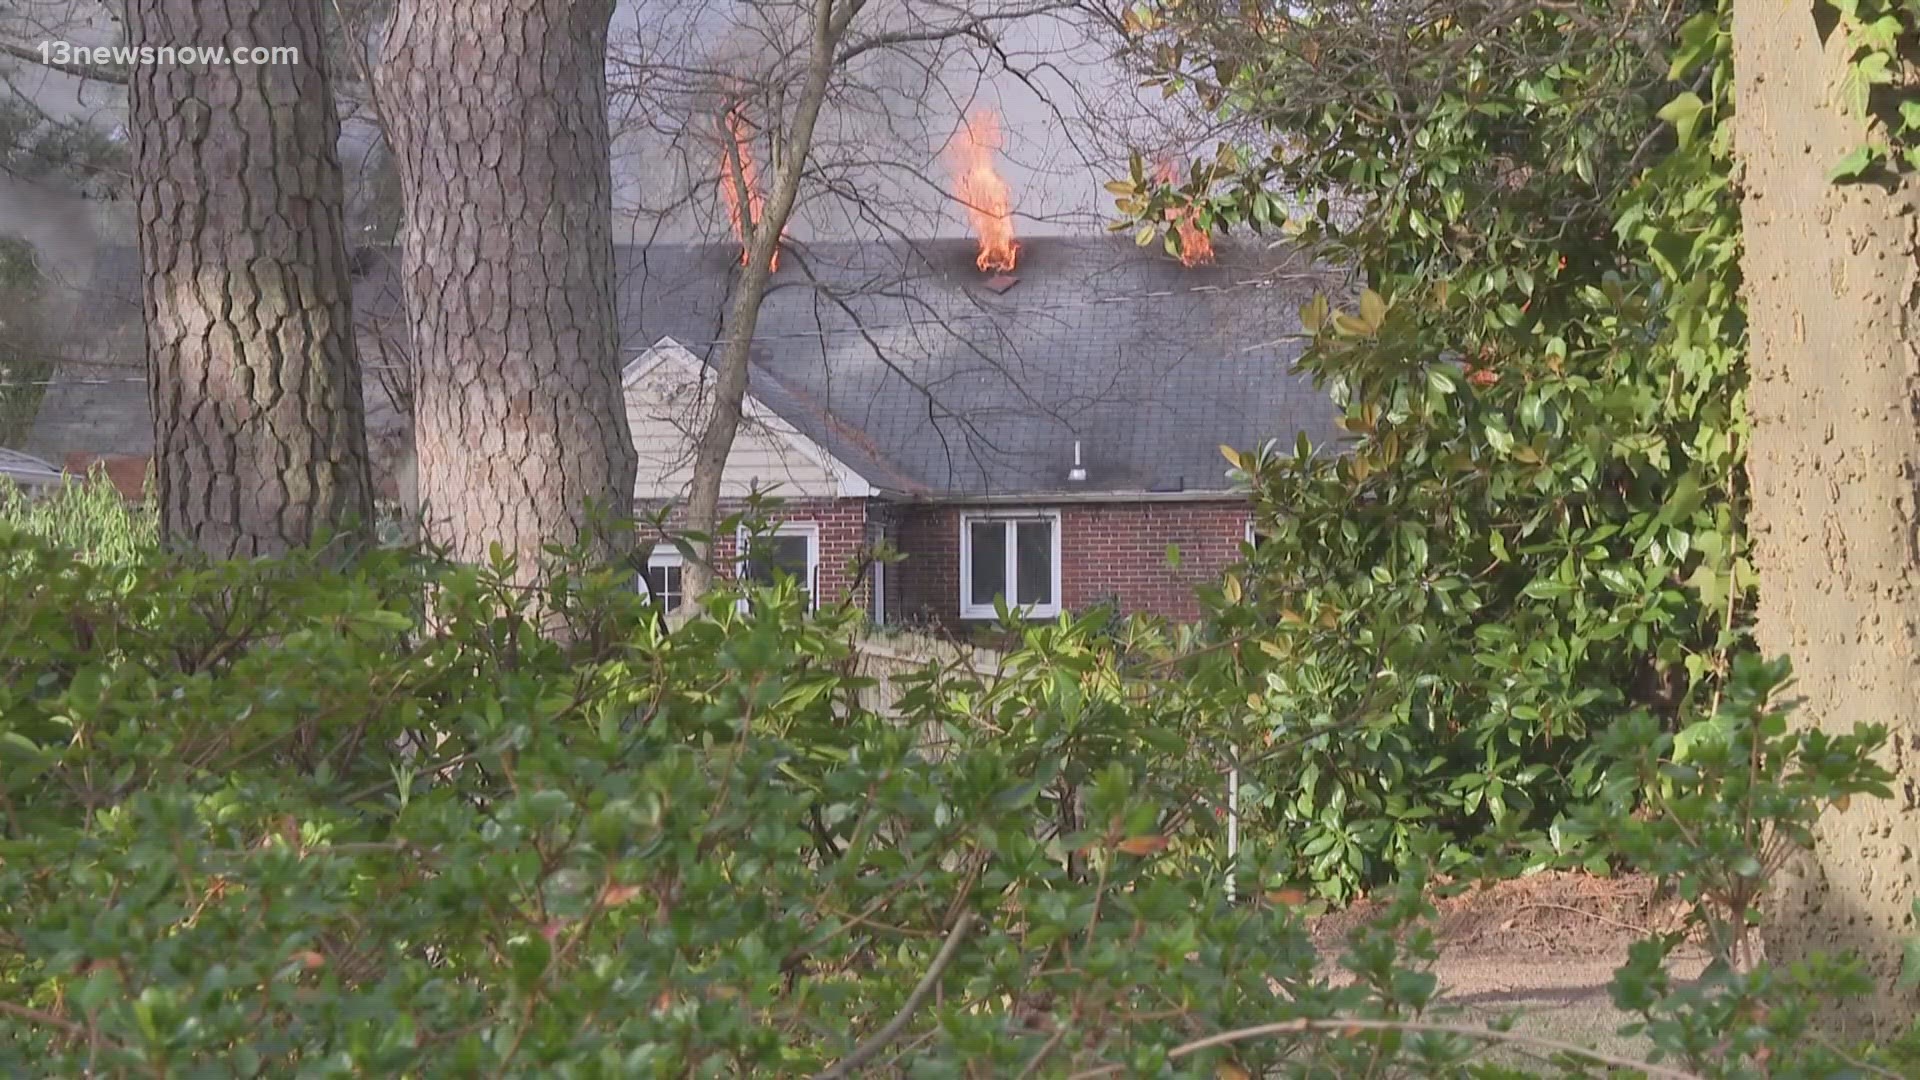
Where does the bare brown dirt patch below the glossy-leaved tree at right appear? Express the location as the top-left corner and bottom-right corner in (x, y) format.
(1313, 872), (1705, 1059)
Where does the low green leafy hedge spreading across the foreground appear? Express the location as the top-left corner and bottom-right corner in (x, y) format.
(0, 532), (1912, 1076)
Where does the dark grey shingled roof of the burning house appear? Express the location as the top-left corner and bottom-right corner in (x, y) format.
(36, 236), (1338, 498)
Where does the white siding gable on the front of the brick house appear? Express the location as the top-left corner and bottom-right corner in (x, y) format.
(620, 338), (874, 500)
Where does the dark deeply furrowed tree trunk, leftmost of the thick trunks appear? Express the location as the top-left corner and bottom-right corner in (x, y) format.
(127, 0), (372, 557)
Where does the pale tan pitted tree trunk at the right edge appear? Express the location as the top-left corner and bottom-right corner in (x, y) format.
(1734, 0), (1920, 1034)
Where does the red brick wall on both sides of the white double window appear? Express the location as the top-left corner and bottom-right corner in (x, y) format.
(893, 500), (1250, 628)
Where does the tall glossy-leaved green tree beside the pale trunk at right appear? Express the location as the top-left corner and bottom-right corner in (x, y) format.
(1117, 0), (1753, 896)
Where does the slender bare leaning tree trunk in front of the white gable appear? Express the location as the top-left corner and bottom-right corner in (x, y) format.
(682, 0), (866, 599)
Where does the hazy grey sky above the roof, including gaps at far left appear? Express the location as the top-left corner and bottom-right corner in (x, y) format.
(0, 0), (1198, 275)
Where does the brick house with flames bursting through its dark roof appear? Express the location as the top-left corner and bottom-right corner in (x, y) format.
(29, 111), (1338, 628)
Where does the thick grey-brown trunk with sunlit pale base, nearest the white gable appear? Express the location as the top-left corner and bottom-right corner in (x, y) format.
(376, 0), (634, 580)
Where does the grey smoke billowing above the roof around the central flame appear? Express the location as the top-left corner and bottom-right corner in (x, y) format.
(609, 0), (1171, 244)
